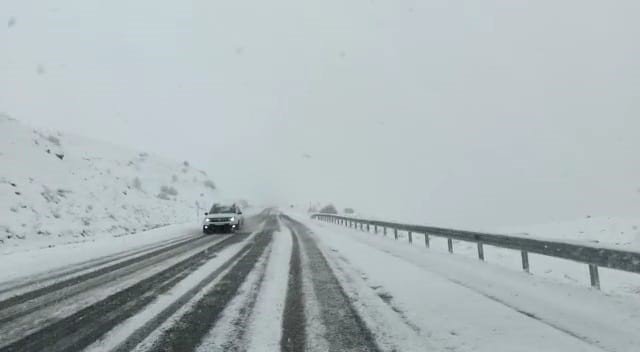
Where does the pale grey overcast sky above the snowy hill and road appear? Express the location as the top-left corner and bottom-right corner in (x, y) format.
(0, 0), (640, 228)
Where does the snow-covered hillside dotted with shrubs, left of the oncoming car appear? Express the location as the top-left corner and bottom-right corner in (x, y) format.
(0, 114), (217, 252)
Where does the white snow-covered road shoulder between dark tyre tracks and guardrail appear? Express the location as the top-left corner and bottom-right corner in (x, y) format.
(298, 215), (640, 351)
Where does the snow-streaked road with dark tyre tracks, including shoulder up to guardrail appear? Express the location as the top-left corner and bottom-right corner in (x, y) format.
(0, 210), (640, 352)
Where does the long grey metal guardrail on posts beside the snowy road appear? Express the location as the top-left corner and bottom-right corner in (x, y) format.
(311, 214), (640, 289)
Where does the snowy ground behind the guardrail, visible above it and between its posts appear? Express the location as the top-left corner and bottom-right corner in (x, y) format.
(322, 210), (640, 296)
